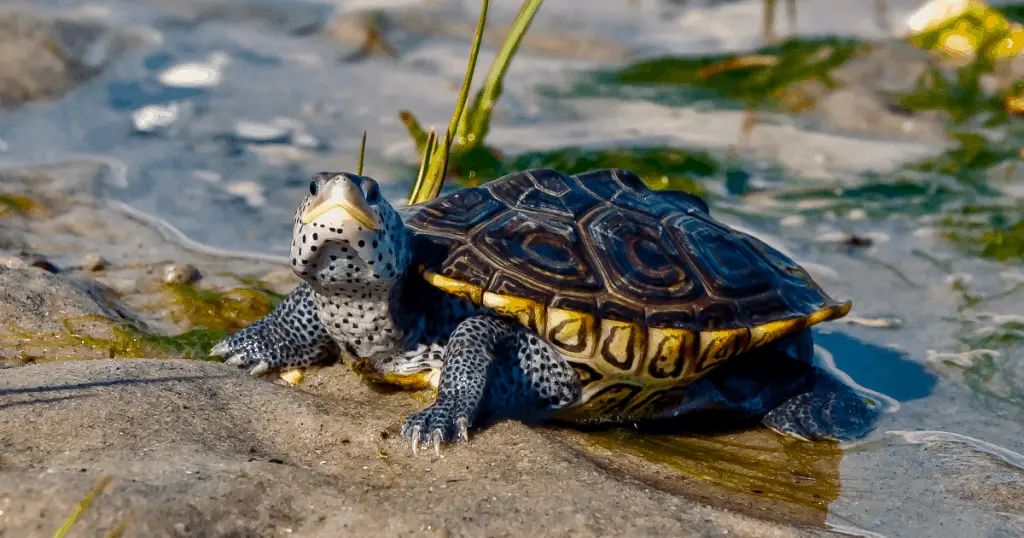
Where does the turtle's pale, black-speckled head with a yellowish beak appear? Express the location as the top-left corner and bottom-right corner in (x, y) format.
(291, 172), (409, 298)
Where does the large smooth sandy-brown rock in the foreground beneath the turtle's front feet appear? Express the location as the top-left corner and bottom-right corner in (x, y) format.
(0, 360), (823, 537)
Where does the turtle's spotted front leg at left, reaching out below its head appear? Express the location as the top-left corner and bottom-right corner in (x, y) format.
(210, 282), (339, 375)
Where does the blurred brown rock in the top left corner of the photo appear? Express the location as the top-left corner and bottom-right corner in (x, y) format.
(0, 11), (134, 108)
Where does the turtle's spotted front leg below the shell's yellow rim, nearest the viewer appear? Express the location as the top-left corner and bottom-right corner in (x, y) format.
(401, 316), (581, 454)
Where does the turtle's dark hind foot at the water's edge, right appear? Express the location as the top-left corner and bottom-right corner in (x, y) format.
(762, 386), (882, 442)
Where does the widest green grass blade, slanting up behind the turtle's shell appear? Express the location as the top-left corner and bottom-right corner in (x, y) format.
(456, 0), (543, 146)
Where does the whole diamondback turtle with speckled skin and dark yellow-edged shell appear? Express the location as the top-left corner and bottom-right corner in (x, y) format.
(211, 169), (879, 452)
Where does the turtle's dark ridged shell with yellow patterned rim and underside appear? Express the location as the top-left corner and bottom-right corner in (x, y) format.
(407, 169), (851, 418)
